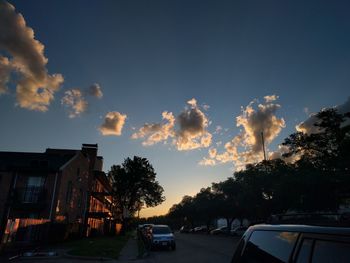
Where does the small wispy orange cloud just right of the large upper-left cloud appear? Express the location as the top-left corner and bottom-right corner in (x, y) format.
(61, 89), (88, 118)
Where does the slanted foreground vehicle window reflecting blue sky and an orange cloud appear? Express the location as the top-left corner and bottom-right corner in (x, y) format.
(241, 231), (298, 263)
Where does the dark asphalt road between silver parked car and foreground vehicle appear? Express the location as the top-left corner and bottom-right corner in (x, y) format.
(146, 233), (239, 263)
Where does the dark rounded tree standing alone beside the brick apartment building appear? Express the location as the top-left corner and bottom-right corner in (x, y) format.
(108, 156), (165, 231)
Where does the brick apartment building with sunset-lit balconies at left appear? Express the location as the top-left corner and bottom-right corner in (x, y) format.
(0, 144), (114, 250)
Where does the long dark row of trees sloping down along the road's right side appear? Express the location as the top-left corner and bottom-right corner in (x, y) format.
(139, 109), (350, 230)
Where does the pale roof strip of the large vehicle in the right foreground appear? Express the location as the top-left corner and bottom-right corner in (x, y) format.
(249, 224), (350, 236)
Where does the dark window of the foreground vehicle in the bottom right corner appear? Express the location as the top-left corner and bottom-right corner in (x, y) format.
(312, 240), (350, 263)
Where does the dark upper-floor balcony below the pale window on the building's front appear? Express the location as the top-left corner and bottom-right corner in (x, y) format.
(13, 186), (47, 210)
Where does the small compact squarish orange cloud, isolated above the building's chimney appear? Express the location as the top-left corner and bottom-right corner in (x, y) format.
(99, 111), (127, 136)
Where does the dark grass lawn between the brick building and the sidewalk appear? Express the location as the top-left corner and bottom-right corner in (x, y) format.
(58, 234), (130, 259)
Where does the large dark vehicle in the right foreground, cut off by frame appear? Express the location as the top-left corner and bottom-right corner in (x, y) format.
(231, 225), (350, 263)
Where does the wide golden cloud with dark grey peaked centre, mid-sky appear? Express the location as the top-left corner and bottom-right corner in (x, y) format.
(131, 98), (212, 151)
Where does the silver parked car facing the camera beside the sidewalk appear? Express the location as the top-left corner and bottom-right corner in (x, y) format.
(151, 225), (176, 250)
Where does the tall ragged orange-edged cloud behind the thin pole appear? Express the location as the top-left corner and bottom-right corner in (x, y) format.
(203, 95), (285, 169)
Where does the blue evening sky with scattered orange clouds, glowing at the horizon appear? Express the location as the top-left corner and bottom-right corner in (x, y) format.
(0, 0), (350, 216)
